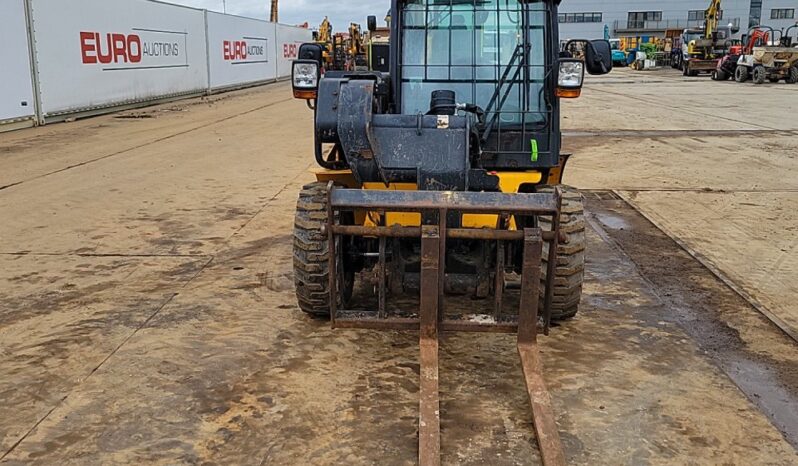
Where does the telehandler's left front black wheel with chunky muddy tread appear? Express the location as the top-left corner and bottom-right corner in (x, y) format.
(294, 183), (354, 317)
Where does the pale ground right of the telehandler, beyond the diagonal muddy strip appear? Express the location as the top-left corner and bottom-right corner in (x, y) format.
(566, 70), (798, 339)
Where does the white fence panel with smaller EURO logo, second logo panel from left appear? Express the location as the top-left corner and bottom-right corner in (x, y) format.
(207, 11), (277, 89)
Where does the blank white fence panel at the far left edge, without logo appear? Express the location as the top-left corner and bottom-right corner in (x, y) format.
(0, 0), (36, 123)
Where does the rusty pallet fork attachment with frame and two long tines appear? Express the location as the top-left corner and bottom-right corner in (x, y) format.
(326, 184), (565, 466)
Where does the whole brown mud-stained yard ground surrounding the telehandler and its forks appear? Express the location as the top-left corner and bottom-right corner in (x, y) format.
(0, 70), (798, 465)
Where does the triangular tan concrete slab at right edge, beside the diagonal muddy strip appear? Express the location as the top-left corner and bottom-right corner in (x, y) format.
(624, 192), (798, 339)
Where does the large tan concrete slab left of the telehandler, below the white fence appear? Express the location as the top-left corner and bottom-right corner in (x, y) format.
(0, 86), (312, 255)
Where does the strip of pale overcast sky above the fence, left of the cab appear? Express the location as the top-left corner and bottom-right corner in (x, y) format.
(166, 0), (391, 32)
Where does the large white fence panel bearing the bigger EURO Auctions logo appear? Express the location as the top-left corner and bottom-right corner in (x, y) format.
(30, 0), (208, 117)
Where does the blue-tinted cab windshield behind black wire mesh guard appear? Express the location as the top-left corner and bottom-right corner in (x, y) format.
(399, 0), (549, 126)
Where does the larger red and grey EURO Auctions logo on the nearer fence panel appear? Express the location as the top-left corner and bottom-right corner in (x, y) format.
(80, 28), (188, 71)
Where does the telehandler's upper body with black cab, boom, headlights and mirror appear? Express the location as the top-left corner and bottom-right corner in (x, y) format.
(294, 0), (612, 190)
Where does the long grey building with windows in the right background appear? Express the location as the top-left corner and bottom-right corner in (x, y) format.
(560, 0), (798, 40)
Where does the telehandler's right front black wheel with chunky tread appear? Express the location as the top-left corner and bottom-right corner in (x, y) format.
(539, 185), (587, 320)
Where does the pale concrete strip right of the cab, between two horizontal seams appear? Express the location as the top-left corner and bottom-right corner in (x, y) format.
(564, 133), (798, 195)
